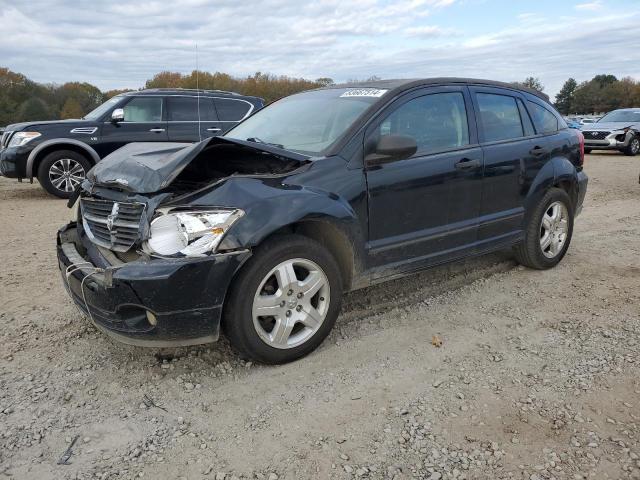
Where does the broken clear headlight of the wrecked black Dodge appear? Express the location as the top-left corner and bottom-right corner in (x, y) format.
(143, 209), (244, 257)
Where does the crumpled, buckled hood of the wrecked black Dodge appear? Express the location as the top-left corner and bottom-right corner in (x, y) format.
(83, 137), (308, 193)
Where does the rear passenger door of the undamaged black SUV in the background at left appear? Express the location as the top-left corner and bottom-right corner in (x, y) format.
(167, 96), (225, 142)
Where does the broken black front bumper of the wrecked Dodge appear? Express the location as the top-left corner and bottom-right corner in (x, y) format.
(57, 223), (251, 347)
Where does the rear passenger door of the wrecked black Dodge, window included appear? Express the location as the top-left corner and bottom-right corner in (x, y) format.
(470, 87), (545, 249)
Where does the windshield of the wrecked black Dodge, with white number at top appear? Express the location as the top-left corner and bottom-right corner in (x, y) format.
(225, 88), (387, 155)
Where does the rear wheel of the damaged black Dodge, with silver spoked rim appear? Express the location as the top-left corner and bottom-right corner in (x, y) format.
(514, 188), (574, 270)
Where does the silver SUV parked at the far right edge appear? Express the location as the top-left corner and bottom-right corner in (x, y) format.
(581, 108), (640, 156)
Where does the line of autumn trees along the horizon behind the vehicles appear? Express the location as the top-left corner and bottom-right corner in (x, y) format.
(0, 68), (640, 126)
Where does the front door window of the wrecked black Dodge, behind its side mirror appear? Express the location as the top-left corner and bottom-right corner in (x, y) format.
(378, 92), (469, 154)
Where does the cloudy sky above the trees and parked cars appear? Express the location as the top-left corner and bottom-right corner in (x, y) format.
(0, 0), (640, 95)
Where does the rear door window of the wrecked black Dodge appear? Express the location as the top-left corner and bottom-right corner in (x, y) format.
(476, 93), (524, 142)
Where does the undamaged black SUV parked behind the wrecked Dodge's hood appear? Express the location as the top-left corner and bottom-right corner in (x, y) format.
(0, 89), (264, 198)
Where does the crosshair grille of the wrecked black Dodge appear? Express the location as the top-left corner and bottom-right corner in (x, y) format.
(80, 198), (146, 252)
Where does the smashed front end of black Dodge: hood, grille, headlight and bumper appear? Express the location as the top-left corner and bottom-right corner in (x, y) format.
(58, 138), (308, 346)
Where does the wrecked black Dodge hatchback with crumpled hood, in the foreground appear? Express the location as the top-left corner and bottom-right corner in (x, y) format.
(58, 78), (587, 363)
